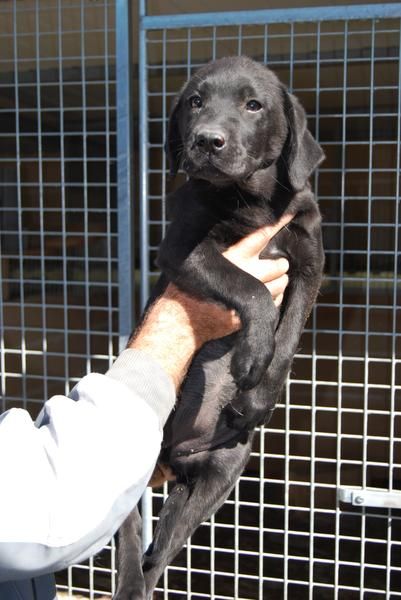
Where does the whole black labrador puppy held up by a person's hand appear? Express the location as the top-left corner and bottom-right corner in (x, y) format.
(116, 57), (324, 600)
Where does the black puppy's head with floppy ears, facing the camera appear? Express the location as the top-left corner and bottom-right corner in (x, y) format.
(167, 57), (323, 190)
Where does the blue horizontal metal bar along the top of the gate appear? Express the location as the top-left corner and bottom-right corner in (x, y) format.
(140, 2), (401, 30)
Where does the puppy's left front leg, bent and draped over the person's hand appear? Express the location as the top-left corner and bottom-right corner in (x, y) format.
(159, 238), (279, 390)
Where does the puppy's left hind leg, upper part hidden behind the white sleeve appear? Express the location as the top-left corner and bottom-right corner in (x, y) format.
(113, 507), (146, 600)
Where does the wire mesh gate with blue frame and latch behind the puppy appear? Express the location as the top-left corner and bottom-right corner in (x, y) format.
(139, 1), (401, 600)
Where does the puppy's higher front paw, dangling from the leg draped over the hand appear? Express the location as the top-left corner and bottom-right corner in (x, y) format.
(231, 334), (274, 390)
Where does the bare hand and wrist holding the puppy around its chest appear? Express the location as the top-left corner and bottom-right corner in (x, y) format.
(129, 217), (290, 389)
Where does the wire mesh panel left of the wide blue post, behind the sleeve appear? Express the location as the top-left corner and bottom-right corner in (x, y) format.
(0, 0), (118, 597)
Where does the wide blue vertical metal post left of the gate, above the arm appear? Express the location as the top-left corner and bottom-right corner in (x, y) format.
(116, 0), (134, 352)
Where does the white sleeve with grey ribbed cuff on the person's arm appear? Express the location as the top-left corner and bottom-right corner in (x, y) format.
(0, 350), (175, 581)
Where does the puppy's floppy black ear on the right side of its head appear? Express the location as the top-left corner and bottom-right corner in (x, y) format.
(284, 90), (324, 191)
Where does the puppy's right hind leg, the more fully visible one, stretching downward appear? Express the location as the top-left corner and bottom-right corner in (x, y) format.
(143, 434), (253, 599)
